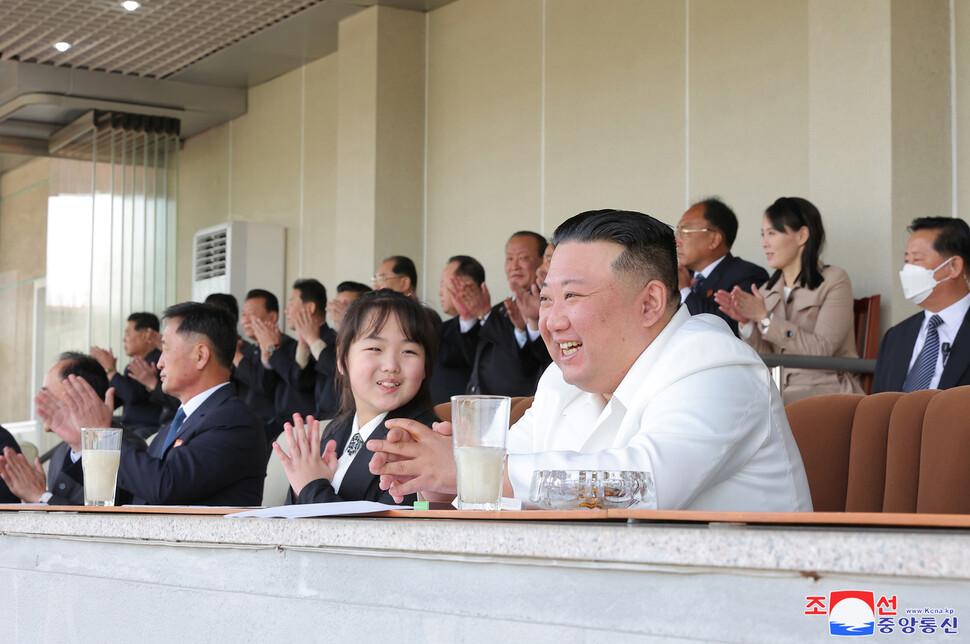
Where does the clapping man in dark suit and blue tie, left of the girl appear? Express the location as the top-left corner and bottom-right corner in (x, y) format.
(38, 302), (266, 506)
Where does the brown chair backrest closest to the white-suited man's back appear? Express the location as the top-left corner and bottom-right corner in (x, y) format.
(785, 394), (864, 512)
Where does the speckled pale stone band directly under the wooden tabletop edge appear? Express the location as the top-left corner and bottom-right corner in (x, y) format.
(0, 512), (970, 580)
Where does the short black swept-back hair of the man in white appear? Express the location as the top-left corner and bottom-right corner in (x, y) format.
(552, 209), (680, 307)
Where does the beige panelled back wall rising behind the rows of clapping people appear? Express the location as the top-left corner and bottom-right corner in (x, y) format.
(179, 0), (952, 328)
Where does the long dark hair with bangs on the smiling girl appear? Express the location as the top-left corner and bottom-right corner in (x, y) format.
(327, 288), (438, 434)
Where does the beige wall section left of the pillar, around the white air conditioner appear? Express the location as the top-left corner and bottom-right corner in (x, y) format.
(178, 55), (340, 300)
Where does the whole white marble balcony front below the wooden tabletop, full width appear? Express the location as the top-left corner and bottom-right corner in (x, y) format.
(0, 512), (970, 644)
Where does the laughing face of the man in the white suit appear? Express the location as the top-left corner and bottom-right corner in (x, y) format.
(539, 241), (656, 394)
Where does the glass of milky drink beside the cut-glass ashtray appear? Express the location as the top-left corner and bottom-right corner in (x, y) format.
(451, 396), (512, 510)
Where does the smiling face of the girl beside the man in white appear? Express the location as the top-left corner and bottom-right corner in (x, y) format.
(340, 315), (425, 426)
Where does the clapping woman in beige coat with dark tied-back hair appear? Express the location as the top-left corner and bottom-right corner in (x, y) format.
(715, 197), (862, 405)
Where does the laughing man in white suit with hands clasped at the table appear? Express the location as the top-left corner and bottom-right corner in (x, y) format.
(367, 210), (812, 512)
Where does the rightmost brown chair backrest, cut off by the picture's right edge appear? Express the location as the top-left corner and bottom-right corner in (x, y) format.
(916, 386), (970, 514)
